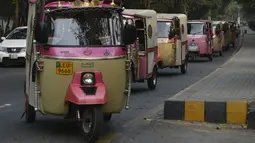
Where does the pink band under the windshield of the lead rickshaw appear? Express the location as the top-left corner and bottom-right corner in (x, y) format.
(40, 47), (126, 57)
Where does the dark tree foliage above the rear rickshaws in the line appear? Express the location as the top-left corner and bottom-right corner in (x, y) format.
(124, 0), (232, 19)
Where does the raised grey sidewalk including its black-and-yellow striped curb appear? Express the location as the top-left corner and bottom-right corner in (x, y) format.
(164, 35), (255, 128)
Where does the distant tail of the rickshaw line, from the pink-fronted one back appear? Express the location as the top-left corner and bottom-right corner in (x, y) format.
(187, 20), (240, 61)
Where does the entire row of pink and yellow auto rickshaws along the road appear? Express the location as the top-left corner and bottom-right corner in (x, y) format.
(23, 0), (241, 142)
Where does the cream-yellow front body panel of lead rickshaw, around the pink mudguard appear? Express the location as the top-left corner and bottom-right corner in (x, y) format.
(39, 47), (127, 115)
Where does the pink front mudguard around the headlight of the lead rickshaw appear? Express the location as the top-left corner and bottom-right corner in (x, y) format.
(65, 71), (107, 105)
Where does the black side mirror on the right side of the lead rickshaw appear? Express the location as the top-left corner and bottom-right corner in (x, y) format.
(123, 24), (137, 45)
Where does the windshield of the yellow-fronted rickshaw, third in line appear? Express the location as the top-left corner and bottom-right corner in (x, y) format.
(157, 21), (173, 38)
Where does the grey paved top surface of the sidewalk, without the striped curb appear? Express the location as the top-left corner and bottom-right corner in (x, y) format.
(171, 36), (255, 101)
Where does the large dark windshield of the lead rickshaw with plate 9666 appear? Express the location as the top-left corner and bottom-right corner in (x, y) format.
(44, 11), (122, 47)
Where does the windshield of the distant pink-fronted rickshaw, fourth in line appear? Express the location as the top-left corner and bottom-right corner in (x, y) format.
(188, 23), (205, 35)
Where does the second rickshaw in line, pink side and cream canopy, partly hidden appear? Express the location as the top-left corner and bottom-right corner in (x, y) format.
(123, 9), (158, 90)
